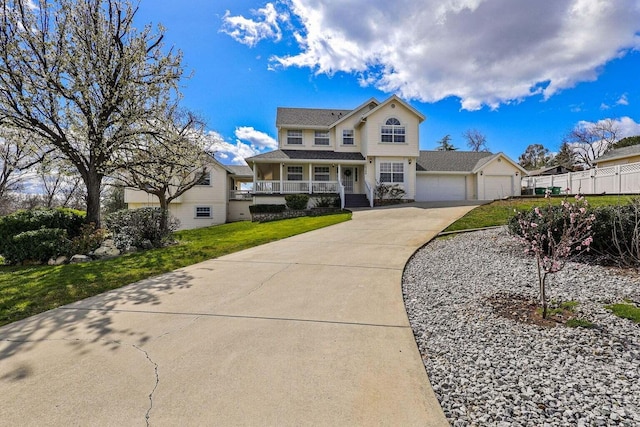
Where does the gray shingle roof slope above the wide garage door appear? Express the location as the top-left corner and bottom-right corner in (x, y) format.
(416, 151), (494, 172)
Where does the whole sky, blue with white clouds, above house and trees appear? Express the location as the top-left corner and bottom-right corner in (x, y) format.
(137, 0), (640, 163)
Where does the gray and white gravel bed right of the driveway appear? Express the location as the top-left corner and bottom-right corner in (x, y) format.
(403, 229), (640, 426)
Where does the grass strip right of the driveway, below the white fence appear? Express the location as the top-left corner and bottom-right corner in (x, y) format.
(445, 196), (631, 231)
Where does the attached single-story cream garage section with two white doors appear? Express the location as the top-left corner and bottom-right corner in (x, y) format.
(416, 151), (526, 201)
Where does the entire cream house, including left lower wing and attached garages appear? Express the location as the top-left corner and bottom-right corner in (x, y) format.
(125, 95), (526, 228)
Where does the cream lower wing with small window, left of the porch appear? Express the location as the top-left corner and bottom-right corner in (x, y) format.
(124, 158), (253, 229)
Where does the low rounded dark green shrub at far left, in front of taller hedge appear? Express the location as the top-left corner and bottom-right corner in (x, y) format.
(4, 228), (70, 264)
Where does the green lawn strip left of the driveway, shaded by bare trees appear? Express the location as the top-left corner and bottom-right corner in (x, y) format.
(0, 213), (351, 325)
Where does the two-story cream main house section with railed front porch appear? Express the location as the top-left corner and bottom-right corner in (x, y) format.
(246, 96), (425, 207)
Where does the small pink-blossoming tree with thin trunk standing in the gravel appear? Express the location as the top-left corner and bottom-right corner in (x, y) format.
(516, 192), (595, 318)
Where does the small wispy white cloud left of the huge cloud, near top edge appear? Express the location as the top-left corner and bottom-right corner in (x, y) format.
(220, 3), (288, 47)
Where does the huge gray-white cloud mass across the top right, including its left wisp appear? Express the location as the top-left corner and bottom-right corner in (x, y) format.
(224, 0), (640, 110)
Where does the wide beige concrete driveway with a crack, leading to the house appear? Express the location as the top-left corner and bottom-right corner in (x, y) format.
(0, 205), (480, 426)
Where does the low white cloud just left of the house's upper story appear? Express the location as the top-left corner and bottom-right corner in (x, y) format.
(207, 126), (278, 165)
